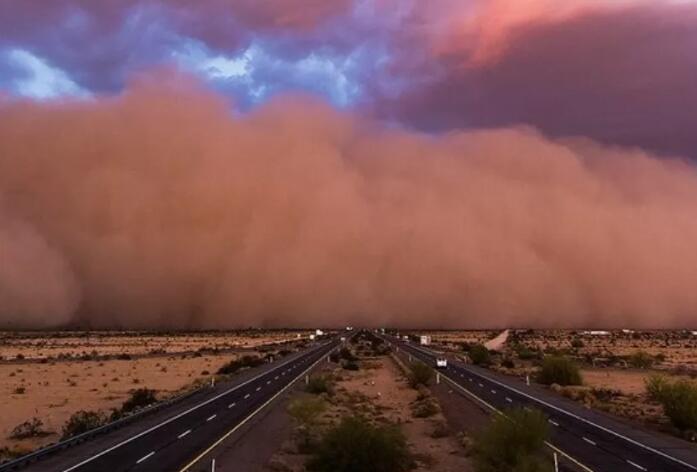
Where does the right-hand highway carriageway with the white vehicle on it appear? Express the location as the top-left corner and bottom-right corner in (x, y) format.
(384, 336), (697, 472)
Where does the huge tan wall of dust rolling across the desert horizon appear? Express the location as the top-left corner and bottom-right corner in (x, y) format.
(0, 76), (697, 328)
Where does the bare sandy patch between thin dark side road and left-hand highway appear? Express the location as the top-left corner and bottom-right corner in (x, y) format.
(0, 354), (245, 449)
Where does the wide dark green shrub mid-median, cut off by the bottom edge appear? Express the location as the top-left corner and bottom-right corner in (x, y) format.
(307, 417), (413, 472)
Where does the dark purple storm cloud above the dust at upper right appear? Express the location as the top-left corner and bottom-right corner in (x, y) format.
(377, 4), (697, 158)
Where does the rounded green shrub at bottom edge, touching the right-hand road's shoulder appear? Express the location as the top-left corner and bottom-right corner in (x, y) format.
(472, 409), (553, 472)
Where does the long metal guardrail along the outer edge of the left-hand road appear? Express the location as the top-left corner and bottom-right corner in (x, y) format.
(0, 385), (209, 472)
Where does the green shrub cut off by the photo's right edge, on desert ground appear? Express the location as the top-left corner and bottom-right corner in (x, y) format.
(646, 376), (697, 431)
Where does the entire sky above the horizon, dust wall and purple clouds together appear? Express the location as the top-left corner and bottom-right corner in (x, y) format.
(0, 0), (697, 327)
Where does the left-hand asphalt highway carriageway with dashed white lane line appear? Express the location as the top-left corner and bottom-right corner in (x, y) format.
(17, 339), (339, 472)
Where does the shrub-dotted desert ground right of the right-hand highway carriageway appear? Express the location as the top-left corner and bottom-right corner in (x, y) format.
(410, 330), (697, 440)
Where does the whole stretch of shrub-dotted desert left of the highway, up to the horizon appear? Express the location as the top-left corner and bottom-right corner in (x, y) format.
(0, 331), (308, 457)
